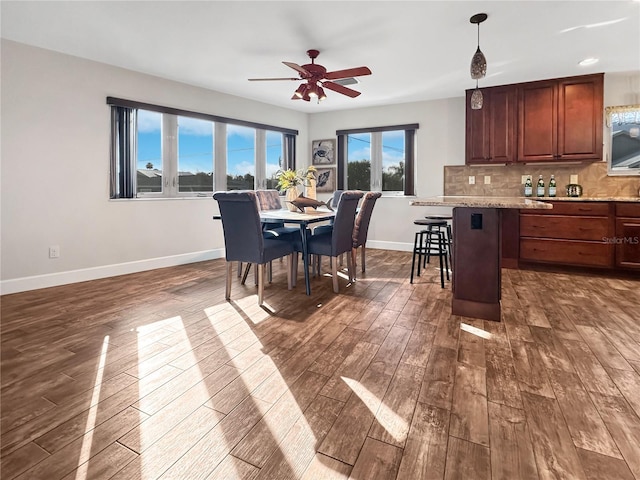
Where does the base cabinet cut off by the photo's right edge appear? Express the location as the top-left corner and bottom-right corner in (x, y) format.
(610, 202), (640, 270)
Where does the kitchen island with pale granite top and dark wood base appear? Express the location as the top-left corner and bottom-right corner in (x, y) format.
(409, 196), (553, 321)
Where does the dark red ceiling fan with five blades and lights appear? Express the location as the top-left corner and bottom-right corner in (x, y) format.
(249, 50), (371, 102)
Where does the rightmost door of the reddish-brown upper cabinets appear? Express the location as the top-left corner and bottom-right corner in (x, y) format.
(556, 75), (603, 160)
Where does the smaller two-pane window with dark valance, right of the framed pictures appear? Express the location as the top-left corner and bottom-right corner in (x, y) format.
(336, 124), (418, 195)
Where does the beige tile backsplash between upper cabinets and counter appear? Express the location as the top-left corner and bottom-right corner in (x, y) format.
(444, 162), (640, 197)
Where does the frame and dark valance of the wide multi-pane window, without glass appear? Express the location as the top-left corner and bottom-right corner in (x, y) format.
(107, 97), (298, 199)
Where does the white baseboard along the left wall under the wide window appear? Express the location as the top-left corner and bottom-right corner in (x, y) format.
(0, 248), (224, 295)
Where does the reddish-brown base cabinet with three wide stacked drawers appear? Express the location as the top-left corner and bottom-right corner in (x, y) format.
(520, 202), (615, 268)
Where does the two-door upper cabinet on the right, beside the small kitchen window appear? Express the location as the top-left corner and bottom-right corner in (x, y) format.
(516, 74), (604, 162)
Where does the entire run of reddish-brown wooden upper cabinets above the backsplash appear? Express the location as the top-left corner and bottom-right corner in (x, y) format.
(466, 74), (604, 164)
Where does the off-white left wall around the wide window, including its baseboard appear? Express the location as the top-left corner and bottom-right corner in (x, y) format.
(0, 40), (310, 294)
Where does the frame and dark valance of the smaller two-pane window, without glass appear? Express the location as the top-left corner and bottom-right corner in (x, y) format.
(336, 123), (420, 196)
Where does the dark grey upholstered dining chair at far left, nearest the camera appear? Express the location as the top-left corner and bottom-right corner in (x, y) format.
(213, 190), (294, 306)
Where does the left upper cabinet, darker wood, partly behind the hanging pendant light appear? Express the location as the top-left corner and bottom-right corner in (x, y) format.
(465, 86), (517, 165)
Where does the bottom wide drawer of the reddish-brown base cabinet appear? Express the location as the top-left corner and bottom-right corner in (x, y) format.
(520, 238), (613, 268)
